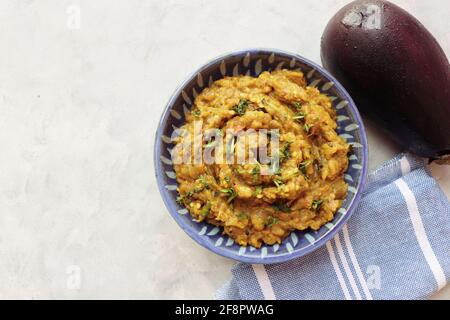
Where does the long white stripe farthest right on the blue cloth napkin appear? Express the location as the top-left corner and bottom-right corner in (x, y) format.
(395, 178), (447, 290)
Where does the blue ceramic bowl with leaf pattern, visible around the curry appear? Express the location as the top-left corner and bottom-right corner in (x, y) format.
(154, 49), (367, 264)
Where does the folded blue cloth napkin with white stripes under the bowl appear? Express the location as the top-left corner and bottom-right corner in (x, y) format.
(216, 154), (450, 299)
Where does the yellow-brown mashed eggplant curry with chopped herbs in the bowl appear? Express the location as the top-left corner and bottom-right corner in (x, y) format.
(172, 70), (349, 248)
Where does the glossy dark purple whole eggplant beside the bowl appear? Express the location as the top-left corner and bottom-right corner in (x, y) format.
(321, 0), (450, 159)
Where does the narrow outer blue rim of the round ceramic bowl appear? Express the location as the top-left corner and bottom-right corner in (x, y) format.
(153, 48), (368, 264)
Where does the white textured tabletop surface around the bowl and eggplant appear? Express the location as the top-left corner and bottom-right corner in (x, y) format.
(0, 0), (450, 298)
